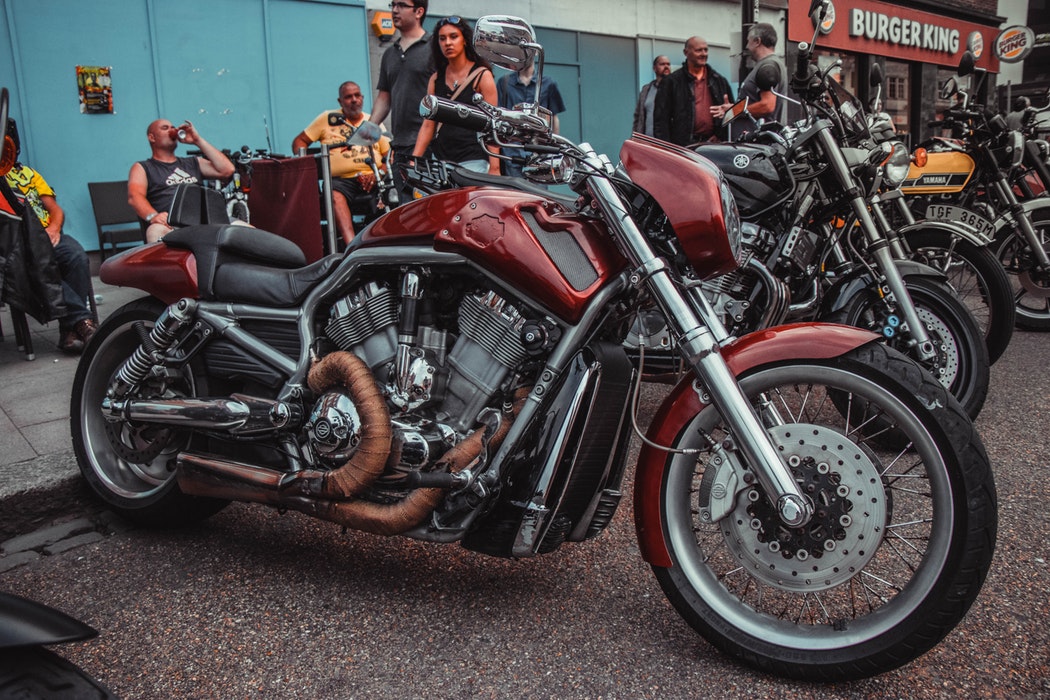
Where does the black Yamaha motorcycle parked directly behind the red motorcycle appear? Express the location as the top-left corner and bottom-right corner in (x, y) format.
(696, 31), (986, 417)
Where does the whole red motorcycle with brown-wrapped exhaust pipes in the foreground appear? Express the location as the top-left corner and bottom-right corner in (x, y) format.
(57, 16), (996, 680)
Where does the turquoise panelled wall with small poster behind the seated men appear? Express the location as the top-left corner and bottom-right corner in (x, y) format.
(0, 0), (373, 255)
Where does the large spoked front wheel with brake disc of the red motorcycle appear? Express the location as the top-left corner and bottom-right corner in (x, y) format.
(653, 343), (996, 681)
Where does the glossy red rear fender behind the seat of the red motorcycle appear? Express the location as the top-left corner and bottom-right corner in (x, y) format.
(99, 242), (200, 304)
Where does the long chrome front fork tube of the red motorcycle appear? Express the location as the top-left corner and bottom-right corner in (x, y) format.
(588, 177), (813, 527)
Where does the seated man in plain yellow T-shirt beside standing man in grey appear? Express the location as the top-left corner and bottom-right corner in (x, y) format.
(292, 81), (391, 243)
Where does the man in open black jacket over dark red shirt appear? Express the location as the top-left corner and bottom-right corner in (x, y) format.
(653, 37), (733, 146)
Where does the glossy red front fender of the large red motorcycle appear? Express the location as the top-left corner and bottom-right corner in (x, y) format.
(634, 323), (878, 567)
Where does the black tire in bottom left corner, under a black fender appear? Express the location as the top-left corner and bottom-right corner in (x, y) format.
(0, 646), (117, 700)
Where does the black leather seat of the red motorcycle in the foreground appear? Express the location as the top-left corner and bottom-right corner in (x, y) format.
(163, 225), (339, 307)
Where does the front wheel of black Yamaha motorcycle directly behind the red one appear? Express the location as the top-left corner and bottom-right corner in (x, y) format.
(823, 277), (990, 418)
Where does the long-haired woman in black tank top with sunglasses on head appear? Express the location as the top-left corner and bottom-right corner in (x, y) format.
(412, 17), (500, 175)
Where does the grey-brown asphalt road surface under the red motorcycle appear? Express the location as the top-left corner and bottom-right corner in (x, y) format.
(0, 333), (1050, 699)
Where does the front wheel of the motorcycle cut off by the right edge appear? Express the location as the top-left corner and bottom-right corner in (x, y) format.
(993, 209), (1050, 332)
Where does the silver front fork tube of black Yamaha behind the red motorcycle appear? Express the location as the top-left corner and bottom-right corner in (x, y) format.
(820, 128), (935, 360)
